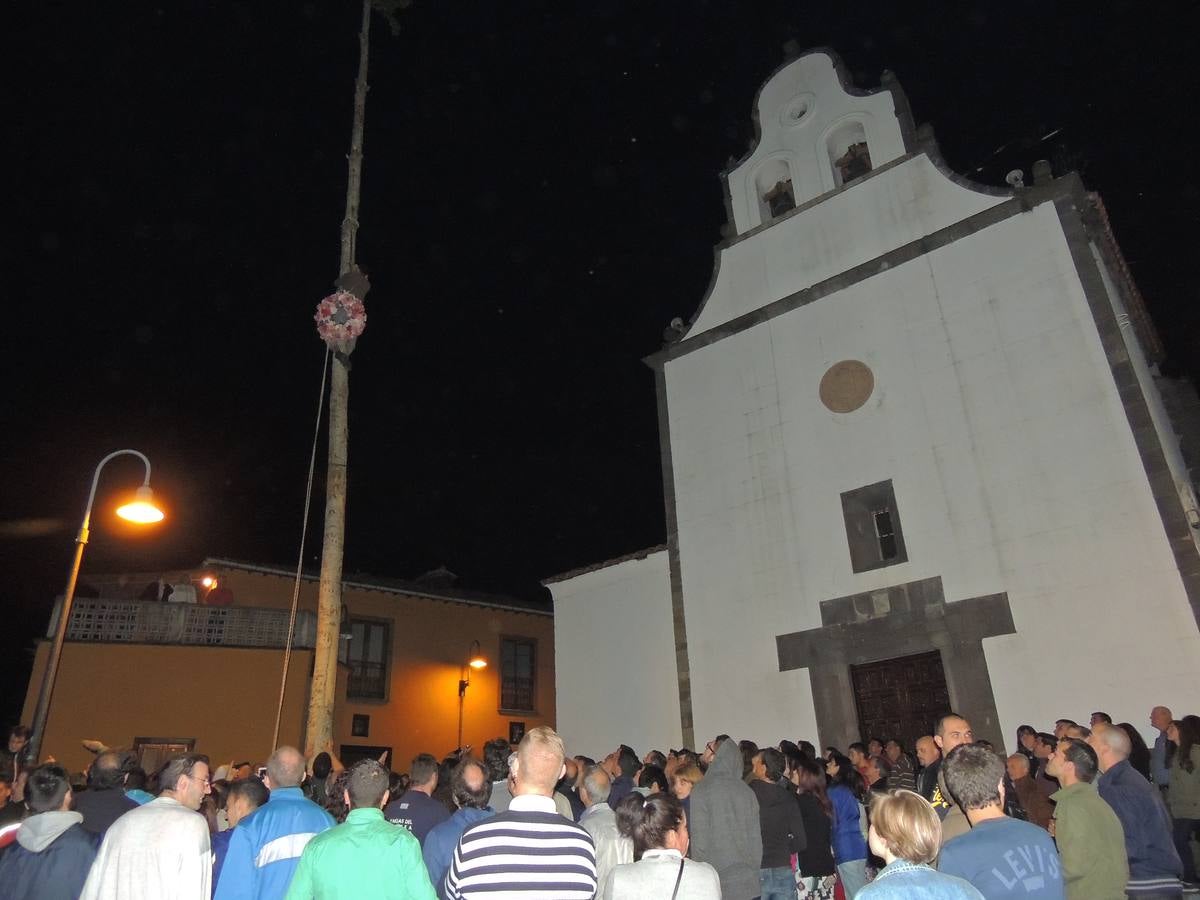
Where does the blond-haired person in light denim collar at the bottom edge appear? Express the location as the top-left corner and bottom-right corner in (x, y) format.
(858, 791), (983, 900)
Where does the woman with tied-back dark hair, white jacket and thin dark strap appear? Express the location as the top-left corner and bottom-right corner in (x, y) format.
(600, 792), (721, 900)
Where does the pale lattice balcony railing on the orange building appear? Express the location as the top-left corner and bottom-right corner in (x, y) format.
(47, 598), (317, 647)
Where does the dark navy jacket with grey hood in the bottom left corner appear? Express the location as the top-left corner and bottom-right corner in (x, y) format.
(0, 811), (100, 900)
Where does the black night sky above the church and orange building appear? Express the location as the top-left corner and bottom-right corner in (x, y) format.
(0, 0), (1200, 718)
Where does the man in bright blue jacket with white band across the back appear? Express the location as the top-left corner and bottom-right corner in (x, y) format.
(214, 746), (336, 900)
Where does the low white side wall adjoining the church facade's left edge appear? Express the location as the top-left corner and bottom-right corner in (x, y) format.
(547, 550), (682, 758)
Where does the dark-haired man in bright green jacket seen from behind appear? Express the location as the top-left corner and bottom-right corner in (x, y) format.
(287, 760), (437, 900)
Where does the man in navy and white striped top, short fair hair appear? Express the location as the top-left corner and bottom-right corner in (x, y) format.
(445, 726), (596, 900)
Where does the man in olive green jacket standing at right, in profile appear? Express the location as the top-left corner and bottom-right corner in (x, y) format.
(1046, 738), (1129, 900)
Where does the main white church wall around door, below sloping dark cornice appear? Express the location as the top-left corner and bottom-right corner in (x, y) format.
(665, 200), (1200, 743)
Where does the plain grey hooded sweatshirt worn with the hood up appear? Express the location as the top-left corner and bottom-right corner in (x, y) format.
(688, 740), (762, 900)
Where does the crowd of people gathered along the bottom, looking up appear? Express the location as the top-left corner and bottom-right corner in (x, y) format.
(0, 707), (1200, 900)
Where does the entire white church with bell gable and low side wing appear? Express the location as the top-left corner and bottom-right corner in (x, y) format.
(546, 50), (1200, 750)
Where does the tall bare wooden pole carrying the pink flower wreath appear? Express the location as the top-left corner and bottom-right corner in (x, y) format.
(305, 0), (371, 758)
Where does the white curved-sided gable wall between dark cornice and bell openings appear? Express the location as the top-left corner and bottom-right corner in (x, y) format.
(689, 153), (1007, 337)
